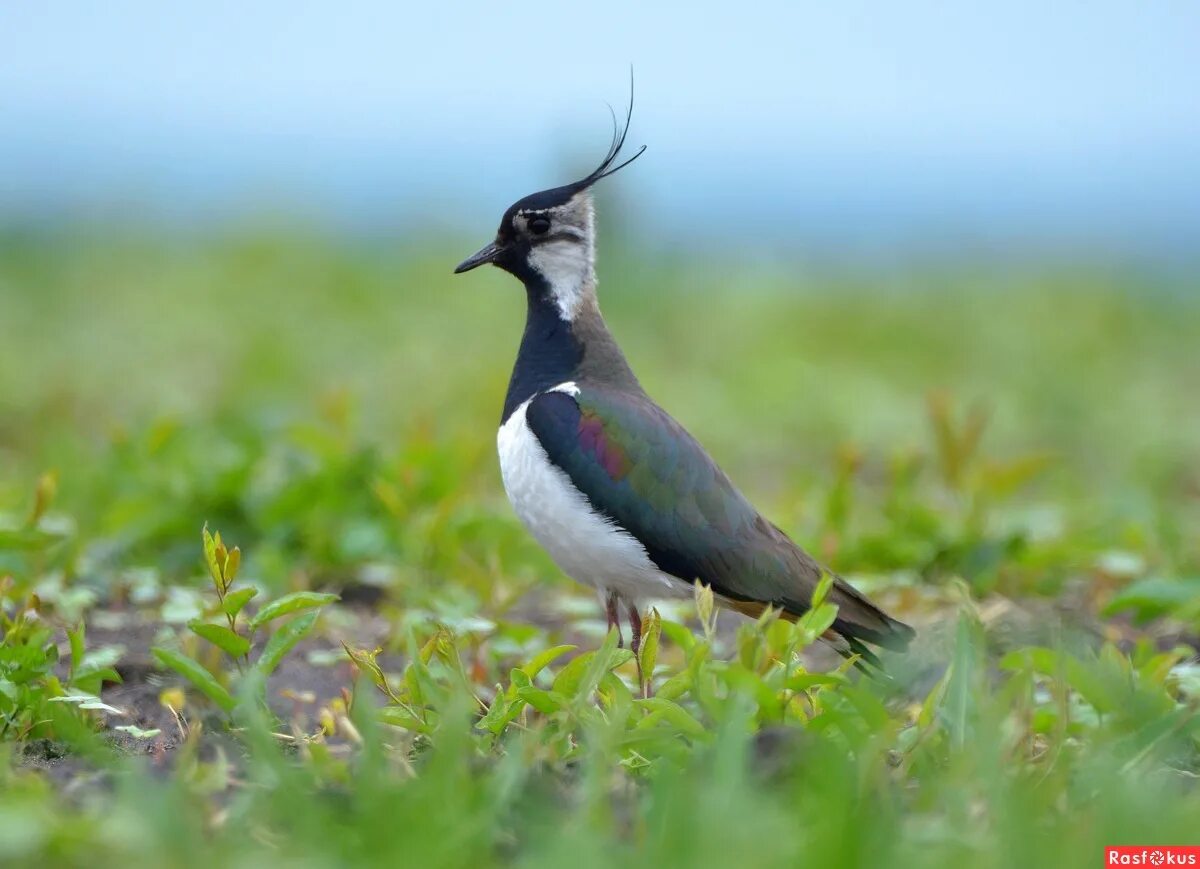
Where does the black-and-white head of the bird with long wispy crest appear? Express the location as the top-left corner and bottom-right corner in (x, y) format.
(455, 88), (646, 320)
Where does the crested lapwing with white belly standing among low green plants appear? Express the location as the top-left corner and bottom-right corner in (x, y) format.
(455, 88), (914, 693)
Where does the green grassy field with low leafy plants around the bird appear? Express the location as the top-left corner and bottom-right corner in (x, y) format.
(0, 220), (1200, 867)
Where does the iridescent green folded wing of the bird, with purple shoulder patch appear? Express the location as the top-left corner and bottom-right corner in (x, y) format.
(526, 385), (912, 648)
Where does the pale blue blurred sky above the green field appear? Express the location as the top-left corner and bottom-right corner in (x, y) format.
(0, 0), (1200, 248)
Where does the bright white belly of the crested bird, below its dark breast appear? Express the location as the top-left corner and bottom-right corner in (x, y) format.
(496, 384), (691, 604)
